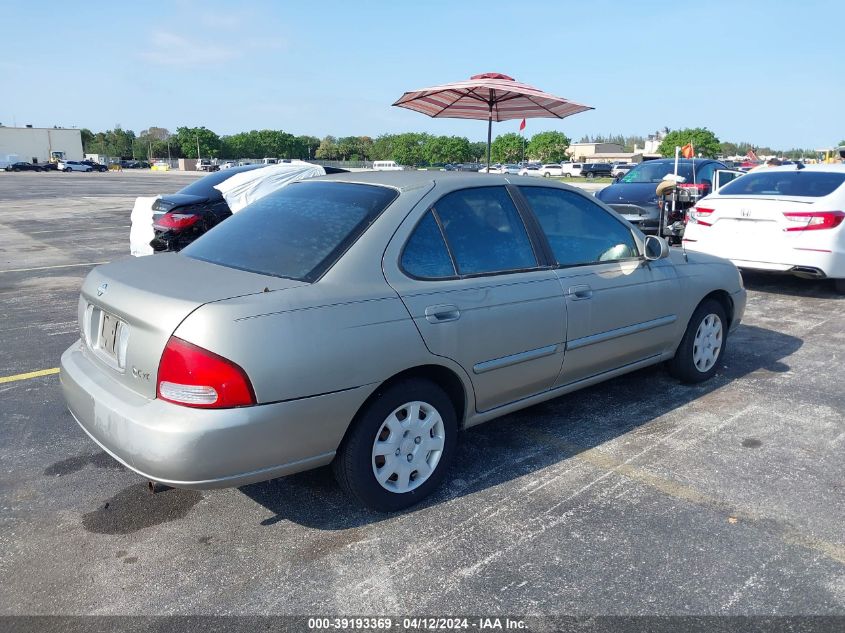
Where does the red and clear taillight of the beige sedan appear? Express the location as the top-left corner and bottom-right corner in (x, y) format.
(156, 336), (255, 409)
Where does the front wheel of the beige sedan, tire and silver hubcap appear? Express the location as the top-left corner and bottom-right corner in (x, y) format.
(668, 299), (728, 384)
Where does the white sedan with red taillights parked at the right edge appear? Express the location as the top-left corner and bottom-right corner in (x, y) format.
(683, 164), (845, 293)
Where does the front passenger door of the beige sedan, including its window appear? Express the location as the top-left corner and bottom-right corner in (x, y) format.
(519, 186), (679, 386)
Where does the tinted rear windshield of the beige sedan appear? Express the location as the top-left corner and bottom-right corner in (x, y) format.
(181, 182), (399, 282)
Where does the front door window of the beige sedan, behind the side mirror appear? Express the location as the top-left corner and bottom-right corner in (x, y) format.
(519, 187), (639, 266)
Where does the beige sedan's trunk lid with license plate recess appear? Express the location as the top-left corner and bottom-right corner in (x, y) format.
(79, 253), (308, 398)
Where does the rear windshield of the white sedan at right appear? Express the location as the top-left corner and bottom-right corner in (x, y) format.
(719, 170), (845, 198)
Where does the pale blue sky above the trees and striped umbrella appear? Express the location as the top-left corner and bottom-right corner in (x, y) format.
(0, 0), (845, 149)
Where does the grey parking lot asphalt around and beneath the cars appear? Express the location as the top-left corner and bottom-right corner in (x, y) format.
(0, 172), (845, 615)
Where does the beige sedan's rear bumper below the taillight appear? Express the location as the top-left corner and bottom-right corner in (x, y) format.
(60, 341), (370, 489)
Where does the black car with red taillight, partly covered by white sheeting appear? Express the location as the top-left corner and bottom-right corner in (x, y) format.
(150, 165), (347, 252)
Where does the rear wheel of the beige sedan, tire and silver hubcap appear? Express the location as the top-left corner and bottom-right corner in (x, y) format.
(332, 379), (458, 512)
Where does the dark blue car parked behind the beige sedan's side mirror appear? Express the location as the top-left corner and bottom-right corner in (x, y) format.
(585, 158), (727, 233)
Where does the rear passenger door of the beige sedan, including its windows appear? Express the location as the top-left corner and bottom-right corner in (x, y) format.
(385, 186), (566, 411)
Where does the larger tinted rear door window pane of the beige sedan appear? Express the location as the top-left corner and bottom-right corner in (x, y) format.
(434, 187), (537, 275)
